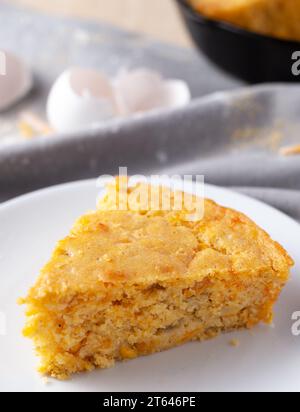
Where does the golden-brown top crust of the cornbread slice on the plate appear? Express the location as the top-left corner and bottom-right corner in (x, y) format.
(25, 180), (292, 299)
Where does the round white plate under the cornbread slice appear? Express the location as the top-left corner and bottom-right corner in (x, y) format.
(0, 181), (300, 392)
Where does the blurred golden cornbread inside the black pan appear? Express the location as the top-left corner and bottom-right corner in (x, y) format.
(188, 0), (300, 40)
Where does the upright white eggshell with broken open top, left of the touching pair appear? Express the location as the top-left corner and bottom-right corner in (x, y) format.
(47, 68), (117, 133)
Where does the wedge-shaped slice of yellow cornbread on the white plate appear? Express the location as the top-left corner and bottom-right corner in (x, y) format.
(24, 180), (293, 379)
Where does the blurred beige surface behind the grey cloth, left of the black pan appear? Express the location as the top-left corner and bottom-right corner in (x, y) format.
(11, 0), (191, 47)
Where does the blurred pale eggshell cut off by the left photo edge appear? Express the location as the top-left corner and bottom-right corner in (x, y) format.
(0, 51), (33, 111)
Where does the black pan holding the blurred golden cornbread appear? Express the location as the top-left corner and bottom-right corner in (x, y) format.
(176, 0), (300, 83)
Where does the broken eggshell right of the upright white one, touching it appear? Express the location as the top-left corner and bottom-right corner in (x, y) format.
(114, 68), (191, 115)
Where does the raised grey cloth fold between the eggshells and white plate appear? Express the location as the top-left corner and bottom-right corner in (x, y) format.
(0, 85), (300, 220)
